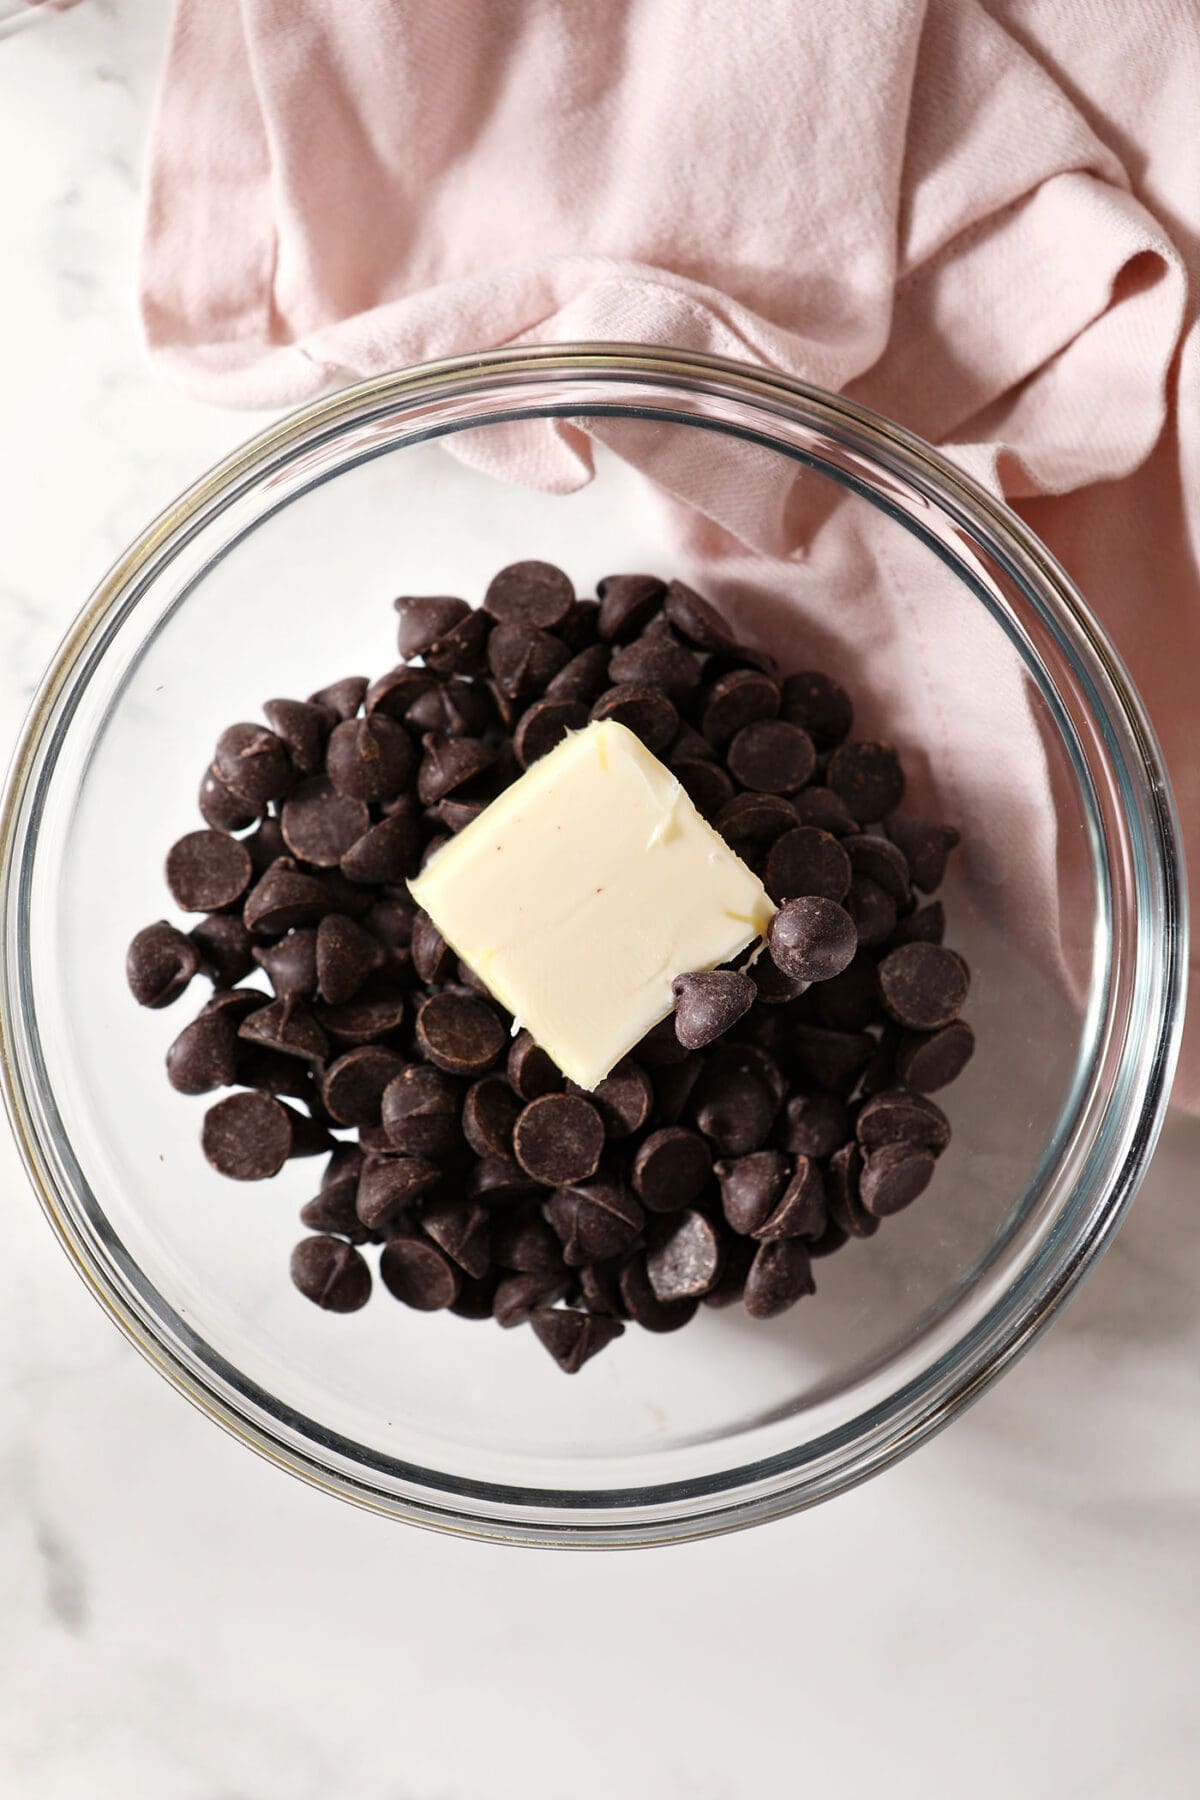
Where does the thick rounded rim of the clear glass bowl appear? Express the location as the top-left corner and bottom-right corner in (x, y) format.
(0, 344), (1187, 1548)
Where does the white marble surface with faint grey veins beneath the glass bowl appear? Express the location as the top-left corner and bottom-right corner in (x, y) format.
(0, 0), (1200, 1800)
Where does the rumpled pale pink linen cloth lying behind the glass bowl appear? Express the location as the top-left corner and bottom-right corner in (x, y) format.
(142, 0), (1200, 1105)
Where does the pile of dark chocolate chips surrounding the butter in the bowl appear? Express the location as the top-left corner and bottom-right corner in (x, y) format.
(128, 562), (973, 1373)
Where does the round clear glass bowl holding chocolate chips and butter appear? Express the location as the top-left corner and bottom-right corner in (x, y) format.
(2, 346), (1186, 1544)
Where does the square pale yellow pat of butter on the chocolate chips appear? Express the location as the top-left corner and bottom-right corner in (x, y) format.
(408, 720), (775, 1089)
